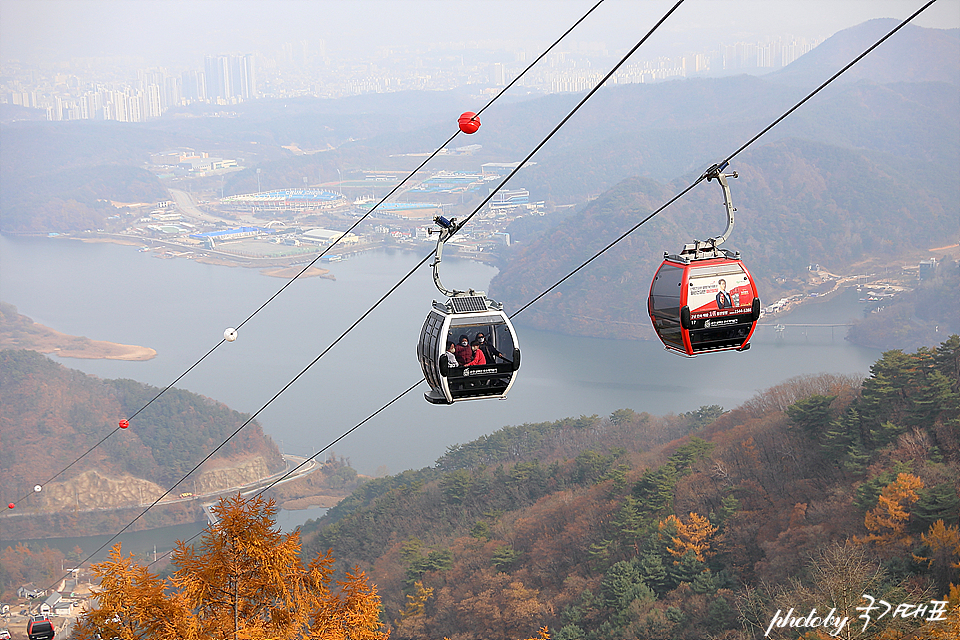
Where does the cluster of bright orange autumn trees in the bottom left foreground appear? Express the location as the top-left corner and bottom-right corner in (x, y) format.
(74, 495), (388, 640)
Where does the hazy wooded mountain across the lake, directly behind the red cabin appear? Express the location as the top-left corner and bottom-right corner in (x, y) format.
(490, 139), (960, 337)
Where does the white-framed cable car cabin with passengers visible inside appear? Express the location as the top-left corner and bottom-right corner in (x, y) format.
(417, 295), (520, 404)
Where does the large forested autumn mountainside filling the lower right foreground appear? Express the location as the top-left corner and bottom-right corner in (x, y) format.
(302, 336), (960, 640)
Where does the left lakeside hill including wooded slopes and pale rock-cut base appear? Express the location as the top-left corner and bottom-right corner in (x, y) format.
(0, 349), (285, 538)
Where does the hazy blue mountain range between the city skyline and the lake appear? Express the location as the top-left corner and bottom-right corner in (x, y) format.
(0, 20), (960, 335)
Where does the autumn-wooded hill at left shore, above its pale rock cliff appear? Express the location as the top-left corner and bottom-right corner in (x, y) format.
(0, 350), (283, 507)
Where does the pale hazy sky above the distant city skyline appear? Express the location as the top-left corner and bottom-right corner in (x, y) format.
(0, 0), (960, 65)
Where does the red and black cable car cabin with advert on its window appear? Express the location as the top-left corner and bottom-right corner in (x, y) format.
(647, 250), (760, 356)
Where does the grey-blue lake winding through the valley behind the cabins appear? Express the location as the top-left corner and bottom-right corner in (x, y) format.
(0, 237), (880, 496)
